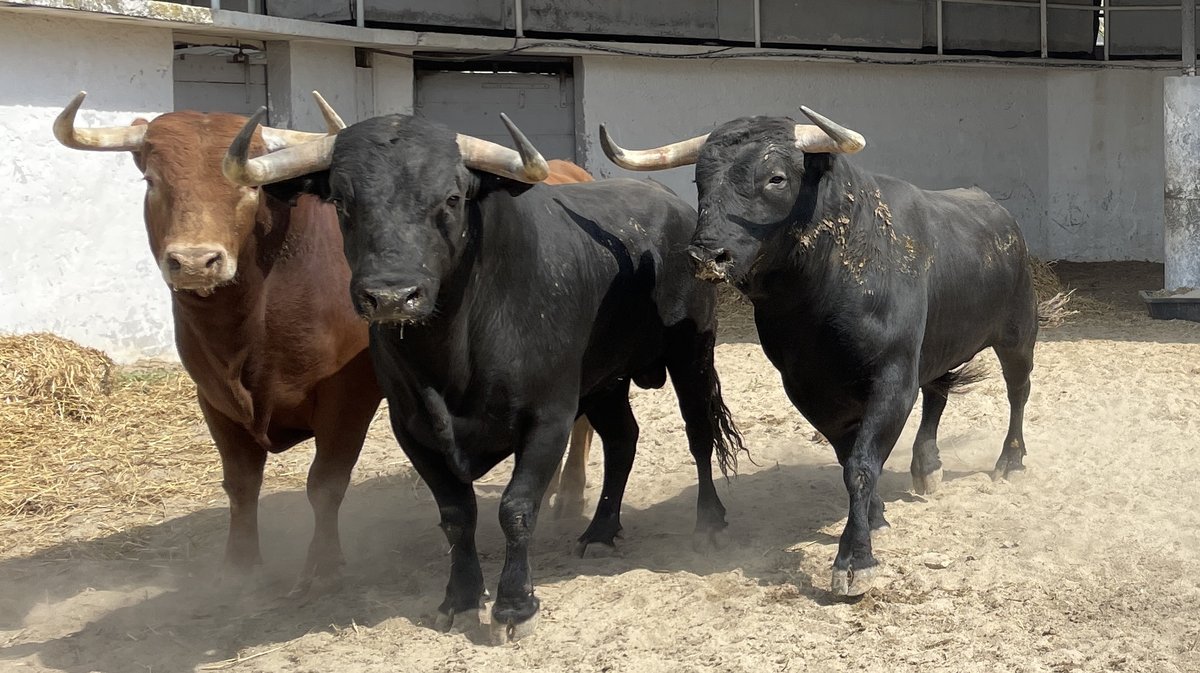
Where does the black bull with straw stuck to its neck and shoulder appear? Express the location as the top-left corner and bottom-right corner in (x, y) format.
(601, 108), (1038, 595)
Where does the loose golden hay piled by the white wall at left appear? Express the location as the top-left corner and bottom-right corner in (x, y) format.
(0, 334), (221, 555)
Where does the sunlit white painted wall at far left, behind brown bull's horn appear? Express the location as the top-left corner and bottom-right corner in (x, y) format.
(0, 13), (174, 360)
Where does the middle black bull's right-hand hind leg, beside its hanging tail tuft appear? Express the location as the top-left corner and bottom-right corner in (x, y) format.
(667, 330), (744, 551)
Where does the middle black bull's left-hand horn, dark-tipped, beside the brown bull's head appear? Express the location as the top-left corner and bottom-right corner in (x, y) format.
(221, 107), (337, 187)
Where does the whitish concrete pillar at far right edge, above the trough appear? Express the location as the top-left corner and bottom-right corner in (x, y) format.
(1163, 77), (1200, 290)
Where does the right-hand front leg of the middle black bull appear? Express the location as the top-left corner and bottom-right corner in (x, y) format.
(492, 409), (575, 644)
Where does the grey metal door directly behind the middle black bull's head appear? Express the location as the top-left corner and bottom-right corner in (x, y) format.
(413, 71), (575, 161)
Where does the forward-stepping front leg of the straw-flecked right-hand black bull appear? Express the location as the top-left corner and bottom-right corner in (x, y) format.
(832, 366), (917, 596)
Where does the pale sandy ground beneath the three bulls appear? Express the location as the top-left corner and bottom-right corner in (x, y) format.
(0, 264), (1200, 673)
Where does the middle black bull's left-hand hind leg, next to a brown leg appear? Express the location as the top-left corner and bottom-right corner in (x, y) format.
(576, 379), (638, 557)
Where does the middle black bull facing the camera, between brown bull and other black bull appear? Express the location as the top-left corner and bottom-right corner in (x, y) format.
(219, 107), (742, 639)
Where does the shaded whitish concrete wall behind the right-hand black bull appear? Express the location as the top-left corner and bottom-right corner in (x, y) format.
(576, 56), (1163, 260)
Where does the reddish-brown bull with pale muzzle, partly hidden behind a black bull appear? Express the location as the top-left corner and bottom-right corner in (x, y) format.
(54, 92), (590, 593)
